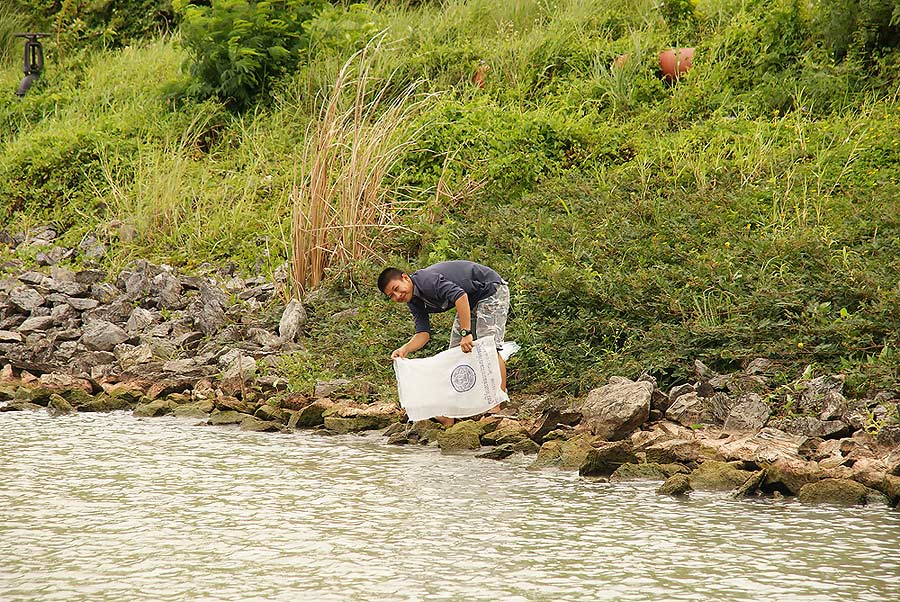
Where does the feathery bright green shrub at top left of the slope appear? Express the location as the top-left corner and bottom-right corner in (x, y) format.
(174, 0), (324, 109)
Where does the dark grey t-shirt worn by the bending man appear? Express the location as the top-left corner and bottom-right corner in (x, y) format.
(406, 259), (504, 332)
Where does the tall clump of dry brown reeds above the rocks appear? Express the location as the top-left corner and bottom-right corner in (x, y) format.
(291, 36), (431, 296)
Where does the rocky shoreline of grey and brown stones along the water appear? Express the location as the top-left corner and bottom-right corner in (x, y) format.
(0, 248), (900, 507)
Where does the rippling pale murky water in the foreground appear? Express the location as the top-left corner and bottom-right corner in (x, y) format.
(0, 412), (900, 601)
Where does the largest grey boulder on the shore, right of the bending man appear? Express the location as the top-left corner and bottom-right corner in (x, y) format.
(579, 377), (653, 441)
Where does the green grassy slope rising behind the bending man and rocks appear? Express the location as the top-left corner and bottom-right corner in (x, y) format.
(0, 0), (900, 400)
